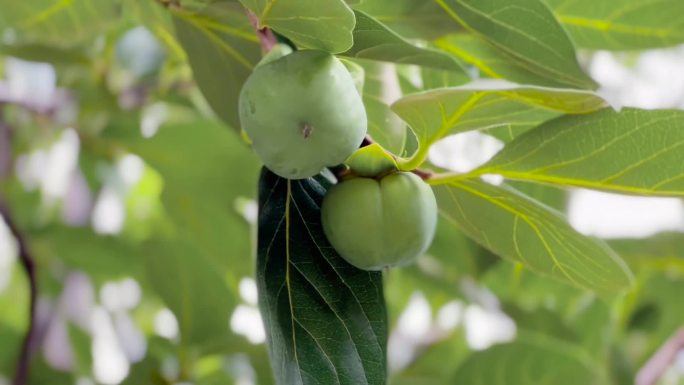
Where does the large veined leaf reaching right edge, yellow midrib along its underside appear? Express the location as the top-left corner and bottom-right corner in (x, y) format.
(474, 109), (684, 196)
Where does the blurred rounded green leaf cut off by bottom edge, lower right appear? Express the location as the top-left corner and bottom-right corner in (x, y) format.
(454, 334), (608, 385)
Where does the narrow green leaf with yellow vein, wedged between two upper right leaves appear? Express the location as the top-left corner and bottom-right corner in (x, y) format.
(435, 33), (584, 88)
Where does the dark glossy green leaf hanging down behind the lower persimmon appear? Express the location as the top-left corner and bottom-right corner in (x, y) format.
(257, 169), (387, 385)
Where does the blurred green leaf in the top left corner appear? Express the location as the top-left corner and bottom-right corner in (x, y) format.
(0, 0), (120, 48)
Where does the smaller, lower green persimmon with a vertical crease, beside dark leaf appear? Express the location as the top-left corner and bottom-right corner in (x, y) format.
(321, 172), (437, 270)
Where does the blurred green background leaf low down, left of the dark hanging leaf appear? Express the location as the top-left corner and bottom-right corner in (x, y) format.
(145, 239), (234, 347)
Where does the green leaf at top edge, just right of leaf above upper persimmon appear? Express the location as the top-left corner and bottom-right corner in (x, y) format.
(353, 0), (454, 40)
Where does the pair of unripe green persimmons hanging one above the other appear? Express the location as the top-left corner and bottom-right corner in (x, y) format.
(239, 47), (437, 270)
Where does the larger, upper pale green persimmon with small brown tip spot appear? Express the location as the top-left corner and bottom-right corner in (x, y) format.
(239, 50), (367, 179)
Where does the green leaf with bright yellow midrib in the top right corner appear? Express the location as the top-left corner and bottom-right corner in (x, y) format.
(545, 0), (684, 50)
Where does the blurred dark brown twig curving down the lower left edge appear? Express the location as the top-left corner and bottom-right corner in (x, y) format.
(0, 201), (38, 385)
